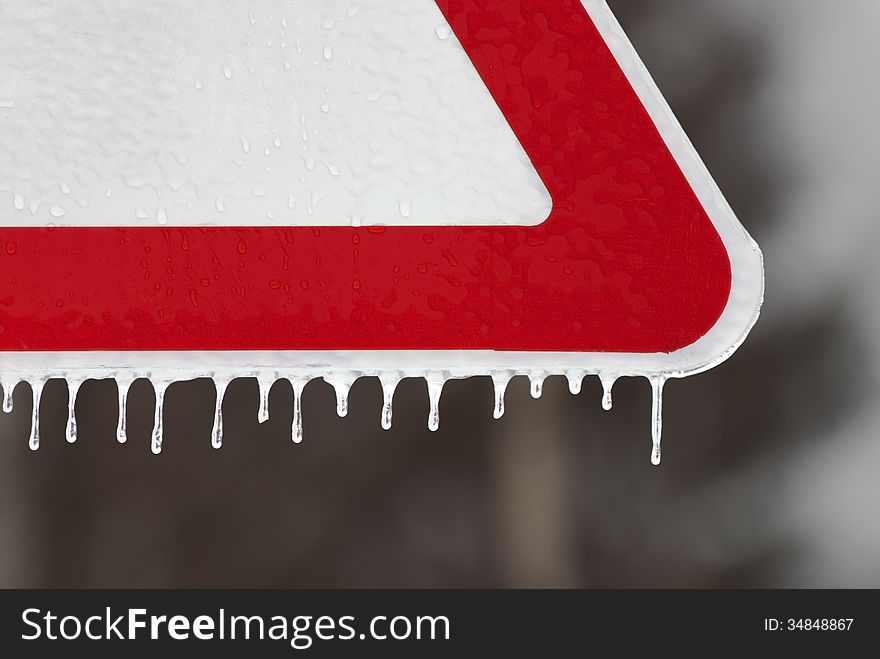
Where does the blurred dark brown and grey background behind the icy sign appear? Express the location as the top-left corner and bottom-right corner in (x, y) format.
(0, 0), (880, 587)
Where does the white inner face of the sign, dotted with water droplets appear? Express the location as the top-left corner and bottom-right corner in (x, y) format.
(0, 0), (551, 226)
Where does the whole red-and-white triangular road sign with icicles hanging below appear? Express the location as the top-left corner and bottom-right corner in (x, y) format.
(0, 0), (763, 460)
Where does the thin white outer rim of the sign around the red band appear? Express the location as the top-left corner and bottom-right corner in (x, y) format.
(0, 0), (764, 382)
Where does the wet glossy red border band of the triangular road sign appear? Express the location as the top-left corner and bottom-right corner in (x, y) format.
(0, 0), (731, 352)
